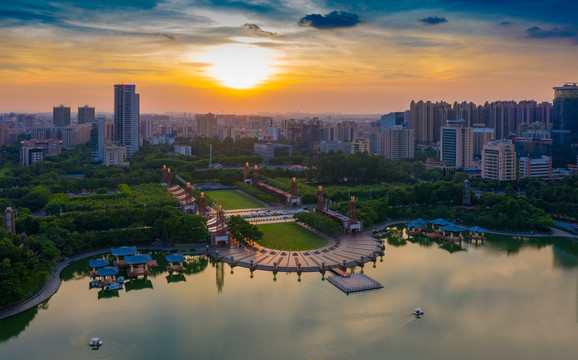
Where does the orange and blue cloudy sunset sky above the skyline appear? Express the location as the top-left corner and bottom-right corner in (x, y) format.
(0, 0), (578, 113)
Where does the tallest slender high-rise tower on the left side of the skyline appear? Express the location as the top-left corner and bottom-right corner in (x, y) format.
(114, 84), (140, 158)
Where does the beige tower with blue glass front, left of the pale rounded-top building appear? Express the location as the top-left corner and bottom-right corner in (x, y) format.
(440, 120), (474, 169)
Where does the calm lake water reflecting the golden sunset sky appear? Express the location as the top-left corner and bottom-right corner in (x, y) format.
(0, 229), (578, 360)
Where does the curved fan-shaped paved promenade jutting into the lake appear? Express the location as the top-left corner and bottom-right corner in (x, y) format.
(211, 234), (382, 272)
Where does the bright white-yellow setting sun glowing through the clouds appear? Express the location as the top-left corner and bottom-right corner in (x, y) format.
(200, 44), (277, 89)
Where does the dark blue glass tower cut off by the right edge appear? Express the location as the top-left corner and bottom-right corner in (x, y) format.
(552, 83), (578, 167)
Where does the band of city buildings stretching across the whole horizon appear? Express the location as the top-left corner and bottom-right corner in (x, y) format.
(0, 83), (578, 181)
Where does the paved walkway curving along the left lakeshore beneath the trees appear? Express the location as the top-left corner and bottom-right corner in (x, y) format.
(0, 244), (205, 320)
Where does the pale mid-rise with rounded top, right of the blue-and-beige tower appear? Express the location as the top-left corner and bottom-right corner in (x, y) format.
(482, 140), (516, 181)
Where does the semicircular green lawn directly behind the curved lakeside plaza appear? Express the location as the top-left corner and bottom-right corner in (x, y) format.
(258, 223), (327, 251)
